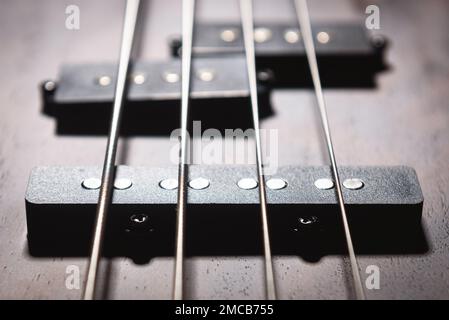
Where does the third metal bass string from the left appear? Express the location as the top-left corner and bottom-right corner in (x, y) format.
(240, 0), (276, 300)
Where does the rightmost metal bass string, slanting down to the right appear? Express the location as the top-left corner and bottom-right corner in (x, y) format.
(295, 0), (365, 300)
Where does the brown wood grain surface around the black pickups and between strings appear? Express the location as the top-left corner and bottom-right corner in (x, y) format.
(0, 0), (449, 299)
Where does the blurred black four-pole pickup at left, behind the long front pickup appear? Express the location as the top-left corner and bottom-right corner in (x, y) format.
(43, 57), (272, 135)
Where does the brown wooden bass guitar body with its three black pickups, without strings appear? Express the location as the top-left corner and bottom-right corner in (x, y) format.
(0, 0), (449, 299)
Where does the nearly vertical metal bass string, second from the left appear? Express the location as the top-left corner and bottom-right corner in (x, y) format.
(173, 0), (195, 300)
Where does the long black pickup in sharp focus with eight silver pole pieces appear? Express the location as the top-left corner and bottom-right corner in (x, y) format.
(25, 165), (427, 260)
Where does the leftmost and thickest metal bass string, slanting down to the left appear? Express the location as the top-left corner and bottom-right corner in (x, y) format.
(83, 0), (140, 300)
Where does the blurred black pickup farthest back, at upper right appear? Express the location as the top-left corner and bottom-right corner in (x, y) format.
(170, 23), (386, 87)
